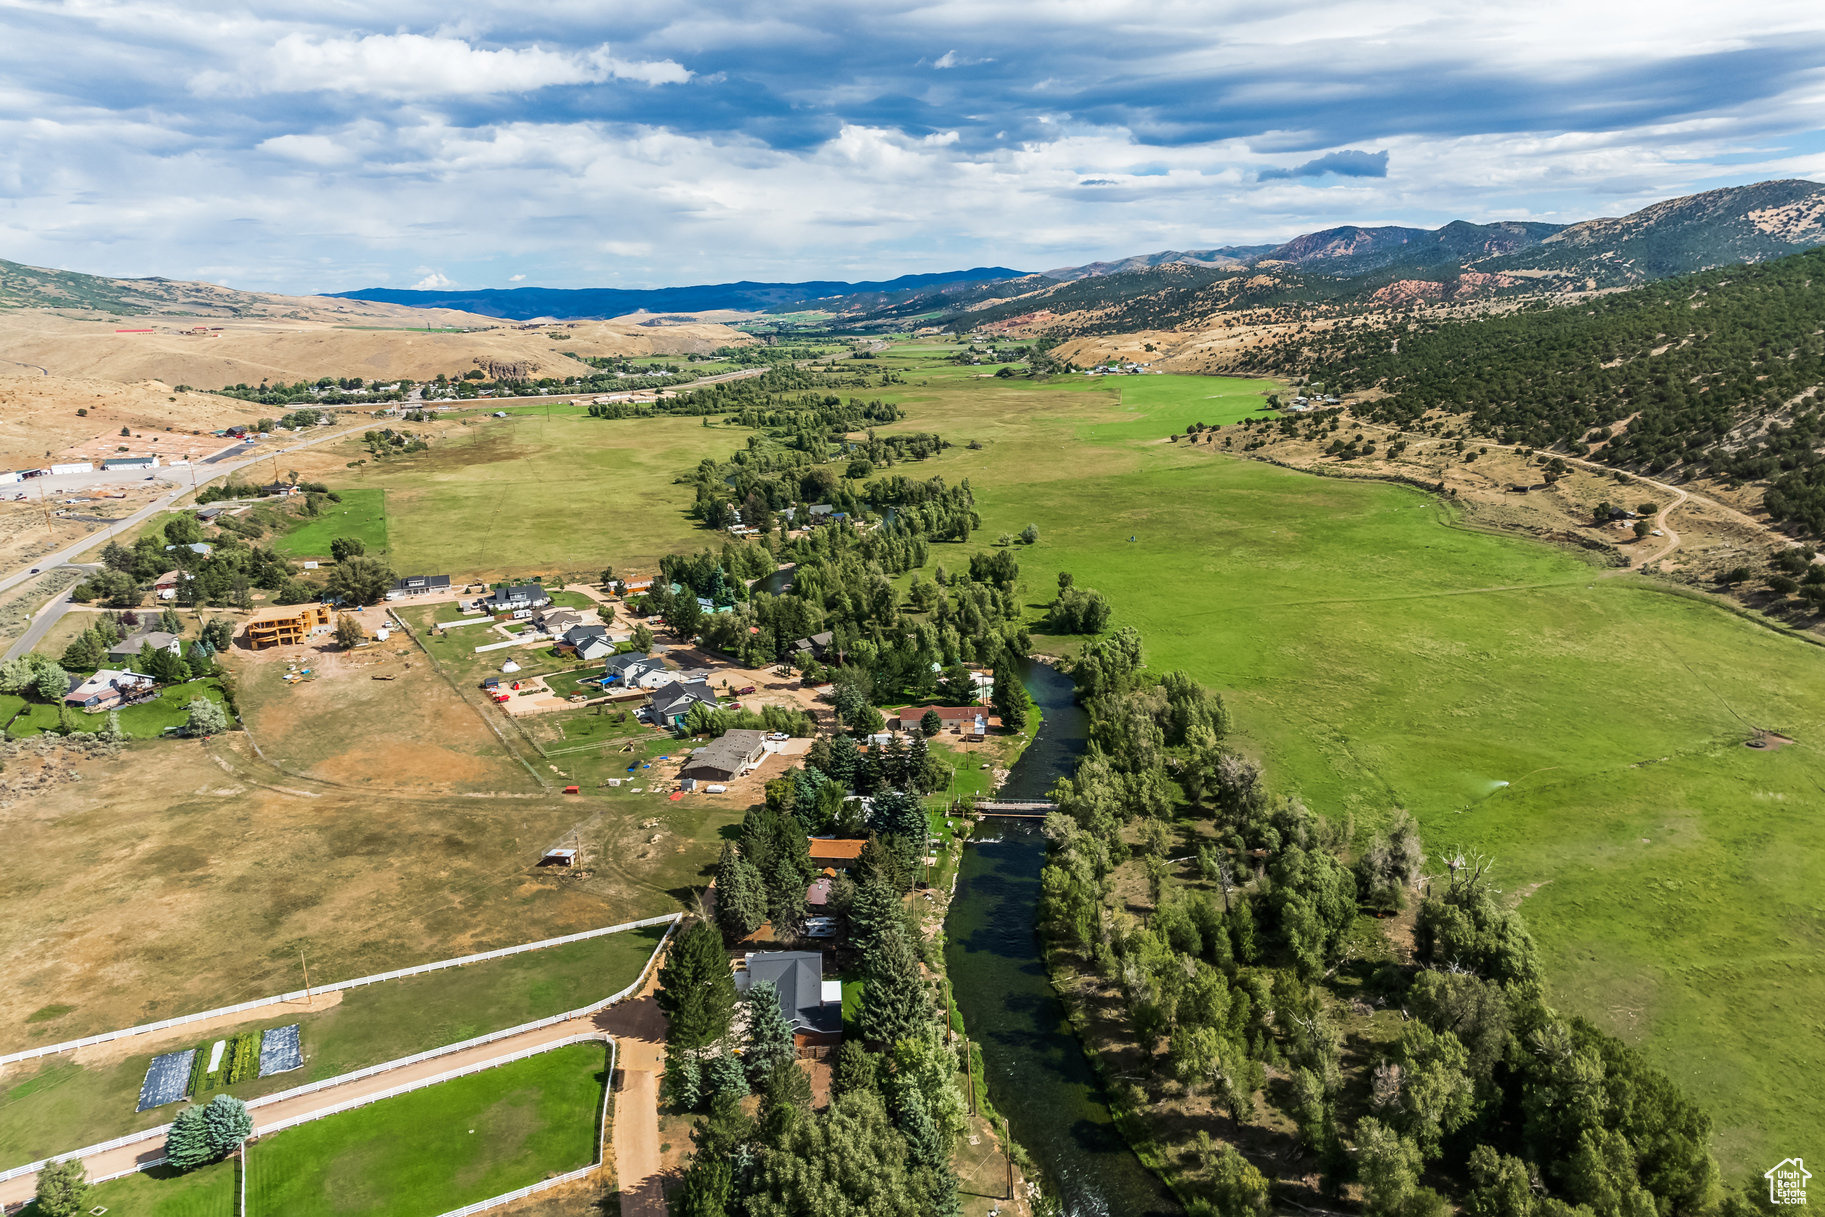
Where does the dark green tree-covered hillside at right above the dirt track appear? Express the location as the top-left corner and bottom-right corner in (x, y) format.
(1270, 250), (1825, 533)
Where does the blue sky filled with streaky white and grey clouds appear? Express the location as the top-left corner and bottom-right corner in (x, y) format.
(0, 0), (1825, 292)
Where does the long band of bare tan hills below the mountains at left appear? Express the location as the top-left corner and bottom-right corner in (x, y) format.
(0, 310), (752, 389)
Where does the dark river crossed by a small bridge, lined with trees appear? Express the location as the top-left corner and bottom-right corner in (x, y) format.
(945, 664), (1184, 1217)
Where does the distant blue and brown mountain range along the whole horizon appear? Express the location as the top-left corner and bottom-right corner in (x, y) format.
(0, 181), (1825, 334)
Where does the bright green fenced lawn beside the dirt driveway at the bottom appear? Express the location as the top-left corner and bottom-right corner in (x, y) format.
(246, 1044), (608, 1217)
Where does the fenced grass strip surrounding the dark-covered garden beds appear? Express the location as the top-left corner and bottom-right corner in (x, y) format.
(0, 925), (664, 1168)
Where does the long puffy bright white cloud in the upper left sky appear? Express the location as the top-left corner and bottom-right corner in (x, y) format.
(192, 31), (692, 100)
